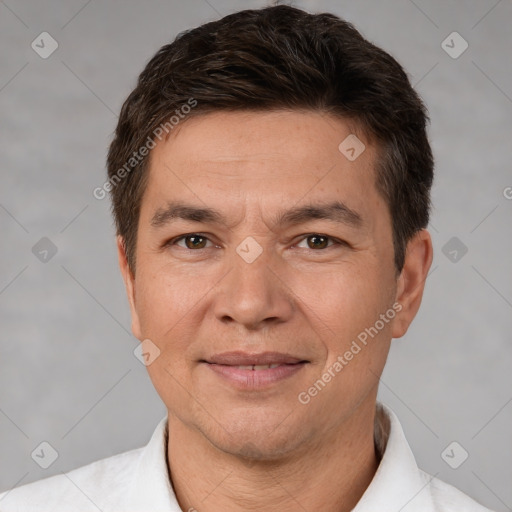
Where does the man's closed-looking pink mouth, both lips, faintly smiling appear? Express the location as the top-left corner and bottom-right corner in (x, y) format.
(200, 352), (309, 390)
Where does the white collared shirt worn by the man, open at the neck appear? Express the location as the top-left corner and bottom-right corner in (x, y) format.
(0, 404), (496, 512)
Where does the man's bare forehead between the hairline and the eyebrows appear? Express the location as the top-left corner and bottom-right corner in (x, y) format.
(142, 111), (380, 223)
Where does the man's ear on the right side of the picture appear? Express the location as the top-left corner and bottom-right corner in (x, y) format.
(392, 229), (433, 338)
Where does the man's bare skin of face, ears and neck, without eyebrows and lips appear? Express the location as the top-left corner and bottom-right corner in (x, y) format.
(118, 111), (432, 512)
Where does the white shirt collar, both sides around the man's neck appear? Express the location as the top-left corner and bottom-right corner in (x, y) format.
(127, 403), (434, 512)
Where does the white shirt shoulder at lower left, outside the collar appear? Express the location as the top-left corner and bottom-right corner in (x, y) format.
(0, 448), (143, 512)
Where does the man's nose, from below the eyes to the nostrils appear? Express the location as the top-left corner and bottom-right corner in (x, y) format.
(213, 249), (294, 330)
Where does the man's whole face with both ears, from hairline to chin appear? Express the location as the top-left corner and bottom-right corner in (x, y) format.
(119, 112), (431, 455)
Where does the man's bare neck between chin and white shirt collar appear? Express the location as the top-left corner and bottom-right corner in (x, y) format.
(167, 401), (378, 512)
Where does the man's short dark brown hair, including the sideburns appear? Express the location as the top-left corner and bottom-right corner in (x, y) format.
(107, 5), (434, 272)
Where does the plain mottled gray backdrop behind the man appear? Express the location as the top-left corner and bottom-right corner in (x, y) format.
(0, 0), (512, 511)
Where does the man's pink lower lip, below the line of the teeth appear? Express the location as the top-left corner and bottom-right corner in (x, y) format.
(206, 363), (306, 389)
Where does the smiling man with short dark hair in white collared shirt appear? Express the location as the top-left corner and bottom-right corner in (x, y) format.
(0, 6), (496, 512)
